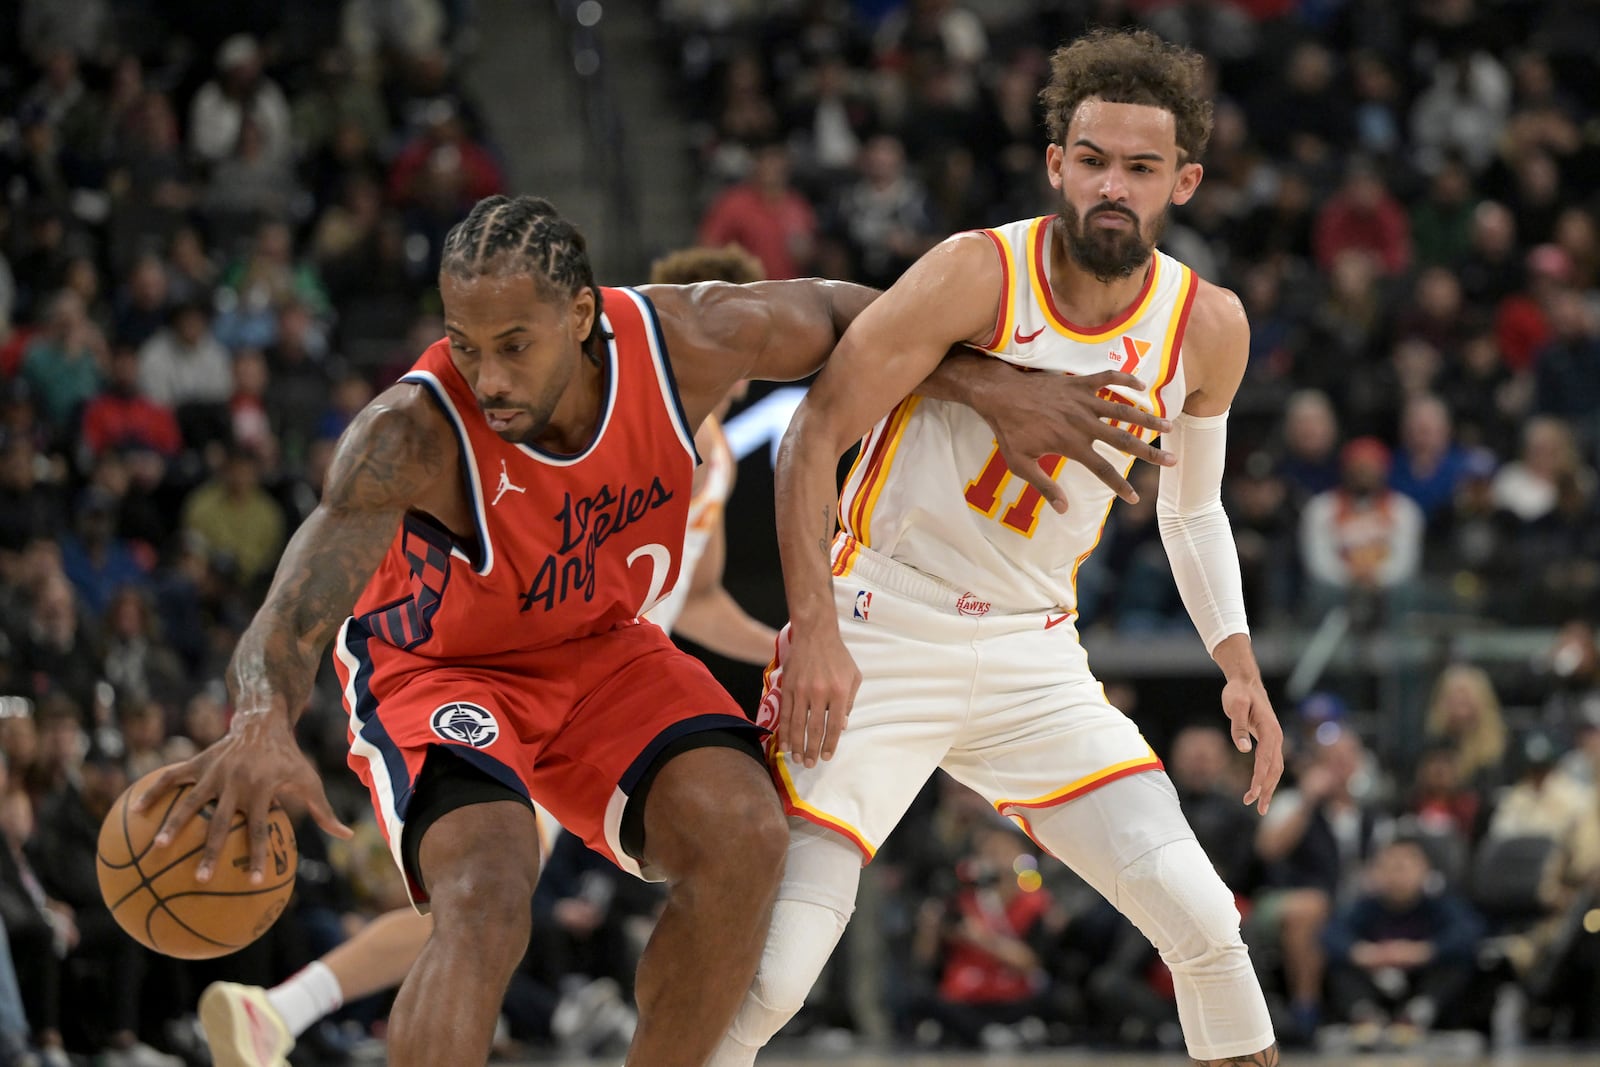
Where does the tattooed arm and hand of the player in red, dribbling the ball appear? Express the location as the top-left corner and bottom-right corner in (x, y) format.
(134, 386), (456, 881)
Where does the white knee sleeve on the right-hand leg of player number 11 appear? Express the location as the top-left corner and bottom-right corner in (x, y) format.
(1114, 838), (1274, 1061)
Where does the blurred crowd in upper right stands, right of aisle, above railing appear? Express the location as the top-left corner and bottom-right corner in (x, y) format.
(661, 0), (1600, 630)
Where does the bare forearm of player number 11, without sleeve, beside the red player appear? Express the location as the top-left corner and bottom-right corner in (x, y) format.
(776, 398), (843, 637)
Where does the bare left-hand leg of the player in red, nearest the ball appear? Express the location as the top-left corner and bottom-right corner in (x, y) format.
(389, 800), (539, 1067)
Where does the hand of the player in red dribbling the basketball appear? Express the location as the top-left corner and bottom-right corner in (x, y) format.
(131, 713), (352, 883)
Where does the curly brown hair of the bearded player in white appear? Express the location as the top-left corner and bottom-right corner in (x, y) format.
(1038, 29), (1211, 163)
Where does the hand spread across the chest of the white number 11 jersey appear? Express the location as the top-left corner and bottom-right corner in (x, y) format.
(981, 371), (1178, 514)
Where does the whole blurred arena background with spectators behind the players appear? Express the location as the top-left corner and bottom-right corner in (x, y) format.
(0, 0), (1600, 1064)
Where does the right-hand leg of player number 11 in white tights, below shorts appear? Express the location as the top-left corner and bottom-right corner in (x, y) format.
(1004, 771), (1278, 1067)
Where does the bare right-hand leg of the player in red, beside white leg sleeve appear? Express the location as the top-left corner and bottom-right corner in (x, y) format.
(627, 747), (789, 1067)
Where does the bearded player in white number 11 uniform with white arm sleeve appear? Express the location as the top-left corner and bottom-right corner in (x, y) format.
(710, 30), (1282, 1067)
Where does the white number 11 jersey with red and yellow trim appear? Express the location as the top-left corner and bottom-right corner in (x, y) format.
(834, 216), (1198, 614)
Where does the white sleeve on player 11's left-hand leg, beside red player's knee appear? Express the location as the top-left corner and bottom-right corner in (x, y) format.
(707, 819), (861, 1067)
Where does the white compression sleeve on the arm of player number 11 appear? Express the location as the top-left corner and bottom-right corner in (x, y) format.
(1155, 411), (1250, 653)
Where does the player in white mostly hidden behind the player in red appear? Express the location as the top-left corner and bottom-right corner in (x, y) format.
(200, 245), (776, 1067)
